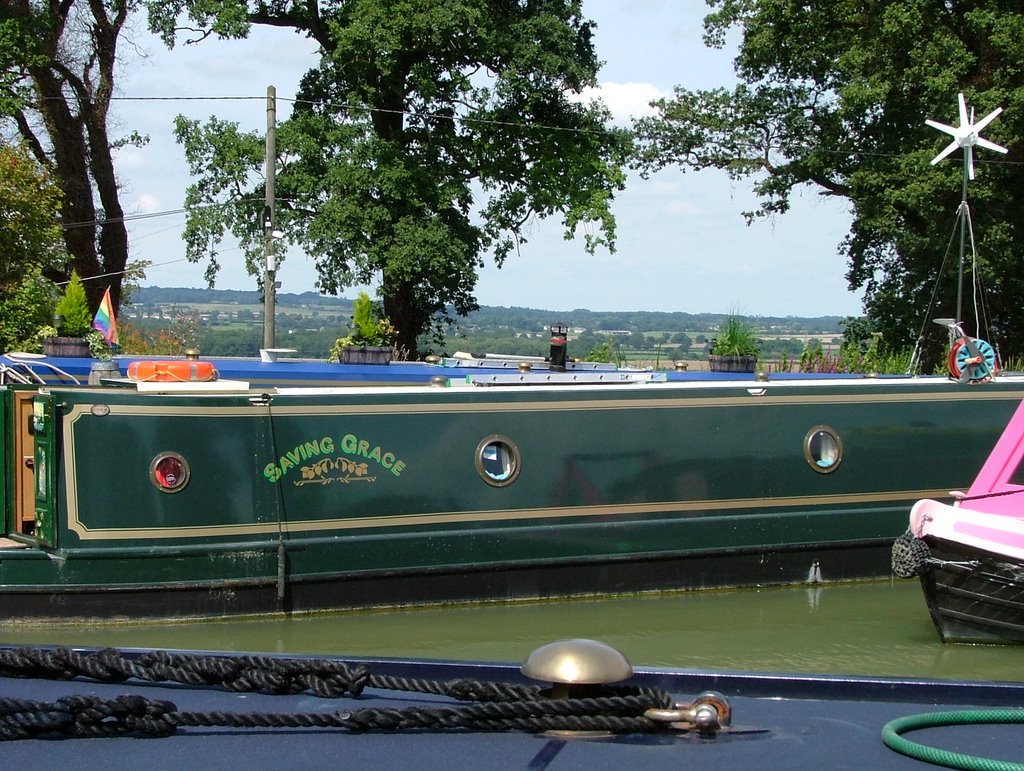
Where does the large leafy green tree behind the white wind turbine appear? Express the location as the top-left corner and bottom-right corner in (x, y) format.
(637, 0), (1024, 359)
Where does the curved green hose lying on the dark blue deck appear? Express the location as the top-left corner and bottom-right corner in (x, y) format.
(882, 710), (1024, 771)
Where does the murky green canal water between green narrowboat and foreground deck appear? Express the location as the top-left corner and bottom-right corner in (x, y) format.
(8, 581), (1024, 681)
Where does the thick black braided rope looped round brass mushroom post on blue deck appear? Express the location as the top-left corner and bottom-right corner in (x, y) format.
(0, 648), (673, 740)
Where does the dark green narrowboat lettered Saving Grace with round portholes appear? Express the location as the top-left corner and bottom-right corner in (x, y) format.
(0, 374), (1024, 622)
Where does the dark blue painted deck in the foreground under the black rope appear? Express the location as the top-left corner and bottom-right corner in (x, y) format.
(0, 659), (1024, 770)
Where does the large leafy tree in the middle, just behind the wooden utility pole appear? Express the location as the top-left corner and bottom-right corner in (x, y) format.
(148, 0), (631, 352)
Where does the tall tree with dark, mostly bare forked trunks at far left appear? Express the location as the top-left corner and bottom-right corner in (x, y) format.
(0, 0), (142, 310)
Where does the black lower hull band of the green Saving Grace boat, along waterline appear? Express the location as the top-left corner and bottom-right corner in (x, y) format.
(0, 542), (888, 623)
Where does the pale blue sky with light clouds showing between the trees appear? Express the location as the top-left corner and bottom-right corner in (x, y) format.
(113, 0), (861, 316)
